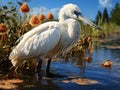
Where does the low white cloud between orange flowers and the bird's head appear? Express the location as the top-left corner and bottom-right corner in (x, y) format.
(29, 7), (59, 18)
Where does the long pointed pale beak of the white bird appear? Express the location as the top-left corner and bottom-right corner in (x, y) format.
(78, 15), (102, 31)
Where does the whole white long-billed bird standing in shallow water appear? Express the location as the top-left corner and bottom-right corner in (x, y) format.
(9, 3), (101, 77)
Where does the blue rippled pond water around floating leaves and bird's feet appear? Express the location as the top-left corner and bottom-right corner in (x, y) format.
(19, 39), (120, 90)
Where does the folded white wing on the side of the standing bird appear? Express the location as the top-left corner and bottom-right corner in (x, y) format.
(9, 23), (61, 60)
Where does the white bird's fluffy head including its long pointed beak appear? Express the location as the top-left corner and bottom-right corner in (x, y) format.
(59, 4), (101, 30)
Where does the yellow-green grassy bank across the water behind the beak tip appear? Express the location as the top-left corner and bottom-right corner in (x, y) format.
(81, 23), (120, 38)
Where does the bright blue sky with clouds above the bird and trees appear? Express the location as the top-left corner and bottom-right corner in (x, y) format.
(0, 0), (120, 20)
